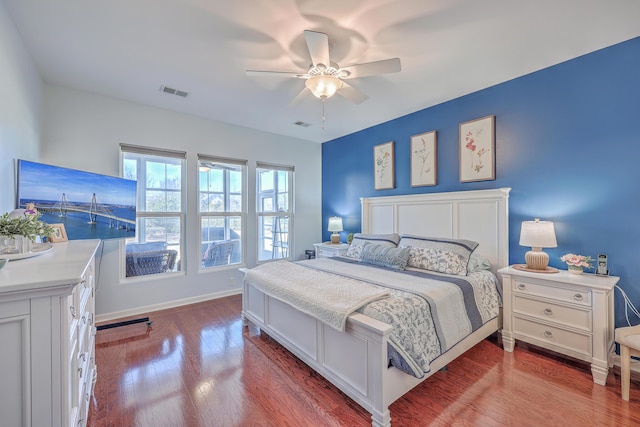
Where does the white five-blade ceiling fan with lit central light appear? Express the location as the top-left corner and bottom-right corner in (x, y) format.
(247, 30), (400, 106)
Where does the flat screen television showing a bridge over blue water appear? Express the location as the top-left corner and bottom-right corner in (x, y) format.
(17, 160), (136, 240)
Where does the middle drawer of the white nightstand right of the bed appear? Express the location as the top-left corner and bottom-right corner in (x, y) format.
(513, 295), (592, 332)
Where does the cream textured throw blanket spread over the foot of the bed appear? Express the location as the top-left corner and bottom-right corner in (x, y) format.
(245, 261), (389, 331)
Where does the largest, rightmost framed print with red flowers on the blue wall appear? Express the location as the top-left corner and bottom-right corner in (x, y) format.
(459, 116), (496, 182)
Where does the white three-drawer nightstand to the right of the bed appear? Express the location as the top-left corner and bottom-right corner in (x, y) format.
(498, 267), (619, 385)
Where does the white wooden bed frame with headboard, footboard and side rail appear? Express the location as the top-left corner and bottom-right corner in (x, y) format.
(242, 188), (510, 427)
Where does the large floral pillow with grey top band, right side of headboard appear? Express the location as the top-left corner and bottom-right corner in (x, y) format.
(398, 235), (478, 276)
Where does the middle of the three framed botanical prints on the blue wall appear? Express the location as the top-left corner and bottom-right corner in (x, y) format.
(411, 130), (438, 187)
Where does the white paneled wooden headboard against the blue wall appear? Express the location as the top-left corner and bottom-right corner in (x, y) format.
(360, 188), (511, 273)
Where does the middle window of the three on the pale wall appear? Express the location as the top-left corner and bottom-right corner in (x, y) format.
(198, 154), (247, 269)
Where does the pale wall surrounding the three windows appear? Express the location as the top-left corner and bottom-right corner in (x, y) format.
(41, 85), (322, 320)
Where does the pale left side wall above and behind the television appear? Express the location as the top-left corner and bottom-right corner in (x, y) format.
(0, 2), (43, 214)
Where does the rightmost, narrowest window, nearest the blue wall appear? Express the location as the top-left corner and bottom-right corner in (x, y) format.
(256, 163), (293, 261)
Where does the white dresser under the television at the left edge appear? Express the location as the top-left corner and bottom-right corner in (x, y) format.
(0, 240), (100, 427)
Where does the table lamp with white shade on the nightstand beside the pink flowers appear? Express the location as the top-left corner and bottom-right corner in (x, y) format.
(520, 218), (558, 271)
